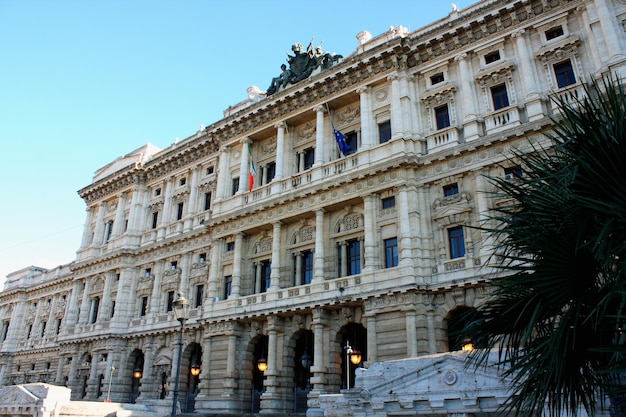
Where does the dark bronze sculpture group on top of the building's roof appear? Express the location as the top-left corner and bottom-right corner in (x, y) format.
(267, 39), (343, 96)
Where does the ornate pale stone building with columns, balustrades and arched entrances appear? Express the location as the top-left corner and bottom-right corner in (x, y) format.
(0, 0), (626, 415)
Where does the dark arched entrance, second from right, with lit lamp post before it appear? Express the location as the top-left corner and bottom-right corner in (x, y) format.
(337, 323), (367, 389)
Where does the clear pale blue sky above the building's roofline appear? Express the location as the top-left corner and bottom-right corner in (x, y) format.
(0, 0), (464, 283)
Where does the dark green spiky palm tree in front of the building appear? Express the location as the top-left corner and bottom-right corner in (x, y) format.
(466, 77), (626, 416)
